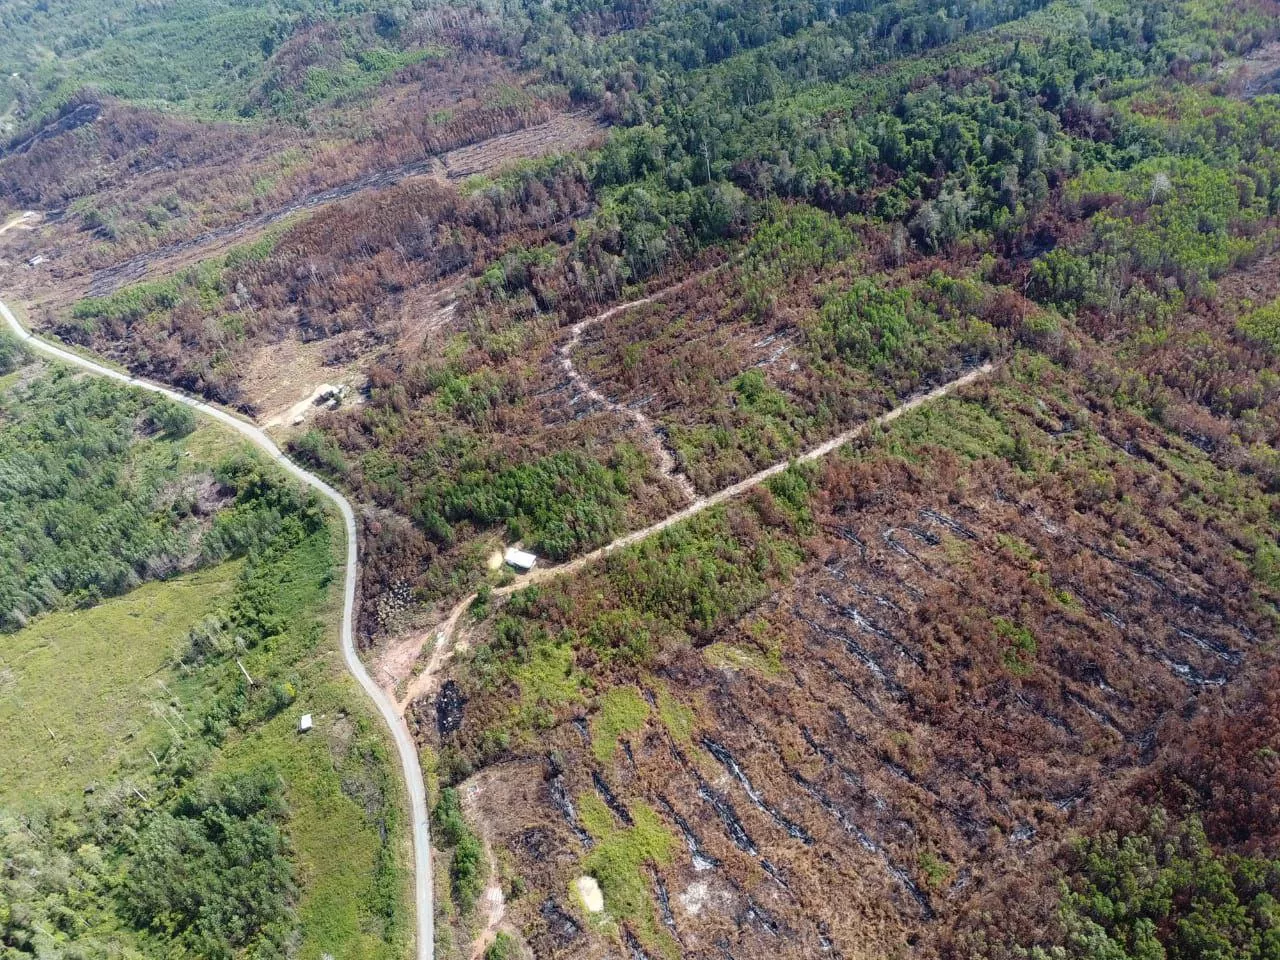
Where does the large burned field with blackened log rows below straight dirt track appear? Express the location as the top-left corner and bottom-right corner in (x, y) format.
(417, 358), (1276, 957)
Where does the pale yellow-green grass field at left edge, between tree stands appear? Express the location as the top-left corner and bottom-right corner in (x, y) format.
(0, 562), (241, 809)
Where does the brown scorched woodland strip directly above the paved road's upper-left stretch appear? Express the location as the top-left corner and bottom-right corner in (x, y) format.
(52, 161), (601, 412)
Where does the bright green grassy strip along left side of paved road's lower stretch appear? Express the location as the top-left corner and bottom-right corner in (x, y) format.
(215, 517), (411, 960)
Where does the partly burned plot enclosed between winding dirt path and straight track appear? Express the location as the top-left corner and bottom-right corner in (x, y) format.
(565, 213), (1005, 493)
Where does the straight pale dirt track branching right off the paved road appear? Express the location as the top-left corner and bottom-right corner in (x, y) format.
(399, 360), (996, 710)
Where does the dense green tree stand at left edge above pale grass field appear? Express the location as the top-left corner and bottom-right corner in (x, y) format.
(0, 353), (198, 630)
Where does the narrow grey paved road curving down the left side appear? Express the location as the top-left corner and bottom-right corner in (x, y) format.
(0, 296), (435, 960)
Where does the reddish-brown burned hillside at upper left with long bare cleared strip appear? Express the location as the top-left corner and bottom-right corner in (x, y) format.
(0, 35), (603, 291)
